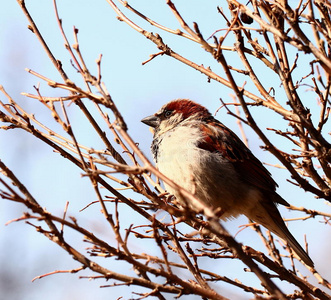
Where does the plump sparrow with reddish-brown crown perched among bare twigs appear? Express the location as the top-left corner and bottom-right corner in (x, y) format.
(141, 99), (314, 267)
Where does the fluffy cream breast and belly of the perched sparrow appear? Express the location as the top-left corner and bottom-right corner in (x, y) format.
(157, 126), (257, 217)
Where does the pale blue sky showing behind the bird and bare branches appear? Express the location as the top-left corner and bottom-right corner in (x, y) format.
(0, 0), (331, 300)
